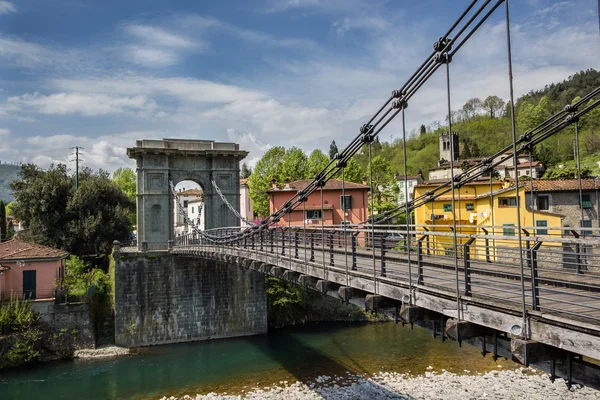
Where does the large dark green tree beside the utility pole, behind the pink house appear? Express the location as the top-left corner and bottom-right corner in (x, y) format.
(11, 164), (135, 255)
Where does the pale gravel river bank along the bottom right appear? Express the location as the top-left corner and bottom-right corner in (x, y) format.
(161, 368), (600, 400)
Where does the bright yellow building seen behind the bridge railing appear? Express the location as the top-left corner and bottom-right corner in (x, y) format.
(414, 180), (563, 258)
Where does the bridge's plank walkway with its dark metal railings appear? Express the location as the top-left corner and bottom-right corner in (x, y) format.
(174, 225), (600, 325)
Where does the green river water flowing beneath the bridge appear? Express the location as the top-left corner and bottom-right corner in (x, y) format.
(0, 323), (516, 400)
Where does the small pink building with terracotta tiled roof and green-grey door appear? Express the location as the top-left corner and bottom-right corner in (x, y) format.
(0, 239), (69, 300)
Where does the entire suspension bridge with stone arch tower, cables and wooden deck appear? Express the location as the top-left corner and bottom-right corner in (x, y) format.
(117, 0), (600, 387)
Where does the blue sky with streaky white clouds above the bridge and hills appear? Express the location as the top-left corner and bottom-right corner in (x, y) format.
(0, 0), (600, 171)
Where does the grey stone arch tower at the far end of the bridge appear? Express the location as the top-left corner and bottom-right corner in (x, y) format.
(127, 139), (248, 249)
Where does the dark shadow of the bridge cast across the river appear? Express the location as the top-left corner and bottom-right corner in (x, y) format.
(248, 324), (413, 399)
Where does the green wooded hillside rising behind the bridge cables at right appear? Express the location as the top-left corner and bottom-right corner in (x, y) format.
(355, 69), (600, 179)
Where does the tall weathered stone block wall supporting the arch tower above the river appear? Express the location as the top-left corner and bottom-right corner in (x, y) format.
(115, 252), (267, 347)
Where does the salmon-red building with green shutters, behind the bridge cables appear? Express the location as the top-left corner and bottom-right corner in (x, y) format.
(268, 179), (369, 226)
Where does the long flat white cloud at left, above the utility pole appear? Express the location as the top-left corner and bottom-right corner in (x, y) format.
(7, 92), (156, 117)
